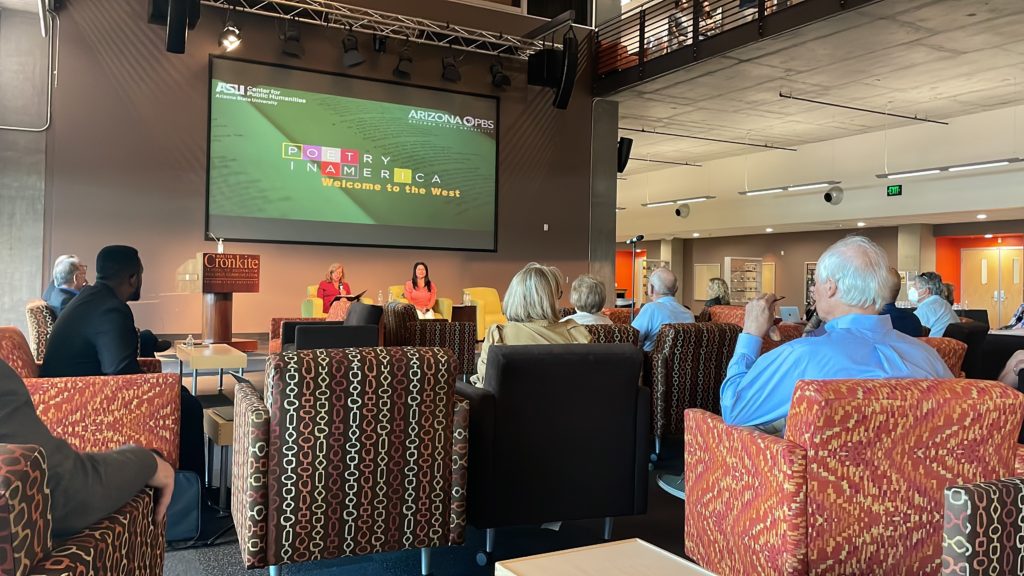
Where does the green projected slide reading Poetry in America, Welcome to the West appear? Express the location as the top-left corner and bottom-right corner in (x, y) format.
(207, 57), (498, 250)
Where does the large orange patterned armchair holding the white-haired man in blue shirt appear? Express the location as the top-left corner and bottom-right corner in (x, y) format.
(684, 379), (1024, 576)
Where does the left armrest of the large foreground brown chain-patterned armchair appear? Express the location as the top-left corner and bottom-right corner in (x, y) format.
(231, 382), (270, 569)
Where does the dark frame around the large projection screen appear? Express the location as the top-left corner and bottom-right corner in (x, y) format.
(203, 53), (502, 252)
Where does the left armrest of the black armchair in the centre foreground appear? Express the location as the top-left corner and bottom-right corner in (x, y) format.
(456, 382), (497, 525)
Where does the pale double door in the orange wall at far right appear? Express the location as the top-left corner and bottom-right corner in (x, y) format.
(961, 246), (1024, 328)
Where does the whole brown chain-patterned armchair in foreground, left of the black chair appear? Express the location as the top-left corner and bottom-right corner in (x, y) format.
(231, 347), (469, 575)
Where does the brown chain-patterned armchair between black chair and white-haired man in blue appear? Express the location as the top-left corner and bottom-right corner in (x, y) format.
(650, 322), (740, 454)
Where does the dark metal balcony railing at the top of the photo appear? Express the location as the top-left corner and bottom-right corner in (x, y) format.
(594, 0), (876, 95)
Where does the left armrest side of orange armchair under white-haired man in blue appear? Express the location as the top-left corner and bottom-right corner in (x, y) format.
(684, 409), (807, 574)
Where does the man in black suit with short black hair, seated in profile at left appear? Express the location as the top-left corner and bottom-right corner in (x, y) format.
(39, 246), (205, 478)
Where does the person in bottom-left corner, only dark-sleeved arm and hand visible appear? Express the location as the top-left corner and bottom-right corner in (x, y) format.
(0, 361), (174, 538)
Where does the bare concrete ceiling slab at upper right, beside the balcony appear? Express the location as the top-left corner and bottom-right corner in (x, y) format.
(610, 0), (1024, 171)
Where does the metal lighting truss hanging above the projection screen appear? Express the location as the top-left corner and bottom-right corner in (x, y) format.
(203, 0), (552, 59)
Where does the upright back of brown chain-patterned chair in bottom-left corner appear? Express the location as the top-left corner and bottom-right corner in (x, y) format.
(0, 444), (53, 575)
